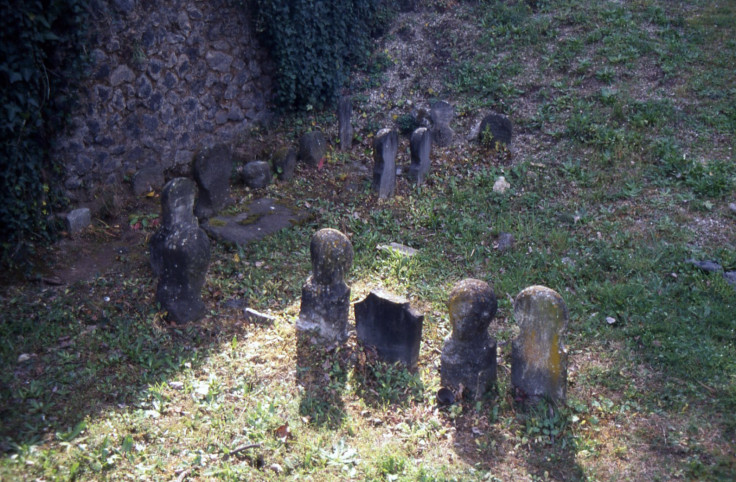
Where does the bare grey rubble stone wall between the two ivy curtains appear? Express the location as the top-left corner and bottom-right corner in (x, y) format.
(53, 0), (271, 202)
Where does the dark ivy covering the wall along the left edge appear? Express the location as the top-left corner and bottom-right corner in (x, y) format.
(0, 0), (88, 264)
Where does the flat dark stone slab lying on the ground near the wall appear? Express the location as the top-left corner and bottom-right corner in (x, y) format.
(202, 198), (307, 244)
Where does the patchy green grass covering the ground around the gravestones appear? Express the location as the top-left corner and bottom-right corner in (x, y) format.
(0, 0), (736, 481)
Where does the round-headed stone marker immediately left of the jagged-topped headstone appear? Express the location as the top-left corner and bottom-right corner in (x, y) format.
(296, 229), (353, 344)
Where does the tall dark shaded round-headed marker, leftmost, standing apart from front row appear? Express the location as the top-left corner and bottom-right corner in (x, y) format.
(151, 178), (210, 324)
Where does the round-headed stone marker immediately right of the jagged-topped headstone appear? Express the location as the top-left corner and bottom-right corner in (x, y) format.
(440, 279), (497, 400)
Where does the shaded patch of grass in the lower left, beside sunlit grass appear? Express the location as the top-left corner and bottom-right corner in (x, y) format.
(0, 273), (249, 454)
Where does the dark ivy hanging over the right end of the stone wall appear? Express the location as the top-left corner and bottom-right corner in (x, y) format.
(251, 0), (390, 108)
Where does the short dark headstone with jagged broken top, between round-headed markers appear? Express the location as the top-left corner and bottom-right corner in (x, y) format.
(355, 290), (424, 370)
